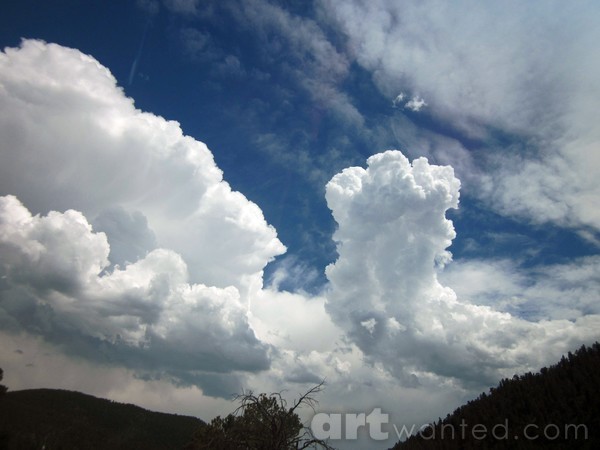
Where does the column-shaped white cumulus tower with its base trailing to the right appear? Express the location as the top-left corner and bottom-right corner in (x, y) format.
(326, 151), (597, 386)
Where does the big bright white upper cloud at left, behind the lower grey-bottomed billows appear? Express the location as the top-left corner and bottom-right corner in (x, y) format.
(0, 41), (285, 296)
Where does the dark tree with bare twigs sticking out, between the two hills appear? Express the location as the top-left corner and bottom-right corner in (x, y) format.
(186, 382), (333, 450)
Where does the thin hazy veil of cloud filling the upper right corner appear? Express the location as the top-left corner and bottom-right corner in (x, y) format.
(319, 0), (600, 233)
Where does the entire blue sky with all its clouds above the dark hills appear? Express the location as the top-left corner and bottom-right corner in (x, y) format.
(0, 0), (600, 448)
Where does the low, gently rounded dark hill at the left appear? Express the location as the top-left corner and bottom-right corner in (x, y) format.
(0, 389), (202, 450)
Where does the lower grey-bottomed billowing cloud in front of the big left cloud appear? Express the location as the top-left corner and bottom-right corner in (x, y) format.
(0, 196), (269, 395)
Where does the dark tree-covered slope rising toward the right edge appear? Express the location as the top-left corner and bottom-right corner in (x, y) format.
(393, 342), (600, 450)
